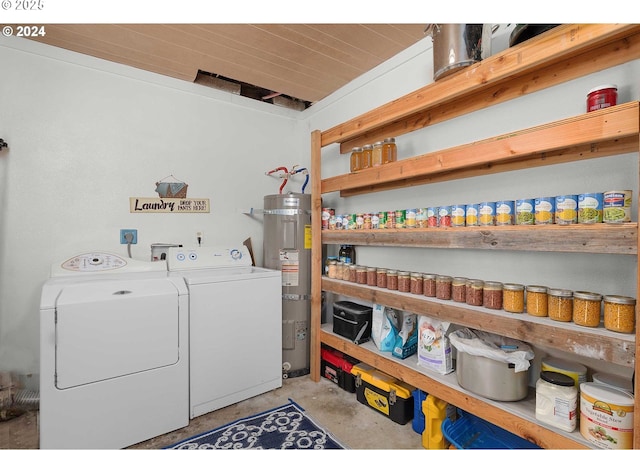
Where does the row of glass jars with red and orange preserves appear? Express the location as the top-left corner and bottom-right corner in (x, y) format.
(326, 260), (636, 333)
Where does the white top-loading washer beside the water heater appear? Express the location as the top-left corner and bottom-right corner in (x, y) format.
(167, 246), (282, 418)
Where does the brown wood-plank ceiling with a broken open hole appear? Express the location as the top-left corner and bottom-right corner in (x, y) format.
(31, 24), (426, 106)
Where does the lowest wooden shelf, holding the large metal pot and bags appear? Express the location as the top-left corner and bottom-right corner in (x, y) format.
(320, 325), (590, 448)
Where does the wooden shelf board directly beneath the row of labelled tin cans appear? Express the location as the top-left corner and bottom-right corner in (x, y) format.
(322, 222), (638, 255)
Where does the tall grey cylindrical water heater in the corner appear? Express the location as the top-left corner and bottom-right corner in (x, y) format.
(263, 193), (311, 378)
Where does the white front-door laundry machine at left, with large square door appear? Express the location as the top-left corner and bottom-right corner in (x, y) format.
(40, 252), (189, 448)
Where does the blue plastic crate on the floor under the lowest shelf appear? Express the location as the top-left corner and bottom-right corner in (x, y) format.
(442, 411), (540, 449)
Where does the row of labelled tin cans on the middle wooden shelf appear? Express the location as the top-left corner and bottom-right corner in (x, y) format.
(322, 190), (632, 230)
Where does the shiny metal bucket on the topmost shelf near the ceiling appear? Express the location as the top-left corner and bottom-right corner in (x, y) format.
(426, 23), (484, 81)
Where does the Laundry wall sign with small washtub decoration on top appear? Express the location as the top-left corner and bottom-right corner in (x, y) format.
(129, 175), (210, 213)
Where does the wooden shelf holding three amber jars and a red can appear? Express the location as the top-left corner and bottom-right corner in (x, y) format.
(321, 102), (640, 197)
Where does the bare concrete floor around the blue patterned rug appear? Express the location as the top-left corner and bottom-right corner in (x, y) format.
(0, 376), (423, 449)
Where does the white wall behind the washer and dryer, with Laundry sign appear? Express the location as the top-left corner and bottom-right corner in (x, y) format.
(0, 38), (309, 373)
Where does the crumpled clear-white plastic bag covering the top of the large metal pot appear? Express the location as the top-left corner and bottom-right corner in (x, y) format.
(449, 328), (535, 372)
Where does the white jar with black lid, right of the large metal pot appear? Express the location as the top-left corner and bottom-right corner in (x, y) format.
(536, 371), (578, 433)
